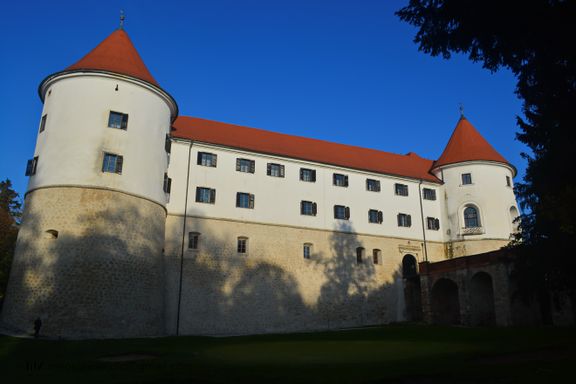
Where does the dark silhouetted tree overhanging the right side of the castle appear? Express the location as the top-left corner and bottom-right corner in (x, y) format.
(396, 0), (576, 320)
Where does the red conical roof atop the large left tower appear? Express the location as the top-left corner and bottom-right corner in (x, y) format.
(66, 29), (159, 87)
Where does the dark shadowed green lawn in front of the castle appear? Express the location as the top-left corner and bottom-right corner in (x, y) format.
(0, 325), (576, 384)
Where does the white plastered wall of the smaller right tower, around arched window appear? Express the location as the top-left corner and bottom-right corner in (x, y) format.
(437, 162), (518, 241)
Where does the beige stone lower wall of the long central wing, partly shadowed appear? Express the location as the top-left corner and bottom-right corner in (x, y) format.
(165, 215), (444, 335)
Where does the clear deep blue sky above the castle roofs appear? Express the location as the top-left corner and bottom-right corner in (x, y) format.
(0, 0), (527, 195)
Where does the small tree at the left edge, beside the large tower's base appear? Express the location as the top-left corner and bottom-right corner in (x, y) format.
(0, 179), (21, 303)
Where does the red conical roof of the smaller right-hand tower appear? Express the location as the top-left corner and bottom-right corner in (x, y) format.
(433, 116), (509, 168)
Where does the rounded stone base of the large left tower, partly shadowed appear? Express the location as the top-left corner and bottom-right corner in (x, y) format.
(2, 187), (166, 338)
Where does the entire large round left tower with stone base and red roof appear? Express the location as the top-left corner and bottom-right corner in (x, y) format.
(2, 29), (177, 337)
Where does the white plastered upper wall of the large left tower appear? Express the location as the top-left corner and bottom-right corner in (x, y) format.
(28, 73), (171, 204)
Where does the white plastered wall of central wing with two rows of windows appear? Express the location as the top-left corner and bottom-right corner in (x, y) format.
(167, 141), (445, 241)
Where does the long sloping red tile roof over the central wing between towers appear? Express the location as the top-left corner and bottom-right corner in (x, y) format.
(172, 116), (440, 183)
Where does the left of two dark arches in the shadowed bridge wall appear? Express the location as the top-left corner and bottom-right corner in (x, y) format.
(431, 278), (460, 324)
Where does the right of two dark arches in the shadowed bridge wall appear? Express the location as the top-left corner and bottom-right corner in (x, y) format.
(470, 272), (496, 326)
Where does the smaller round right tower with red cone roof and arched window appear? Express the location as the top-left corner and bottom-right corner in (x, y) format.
(432, 117), (518, 257)
